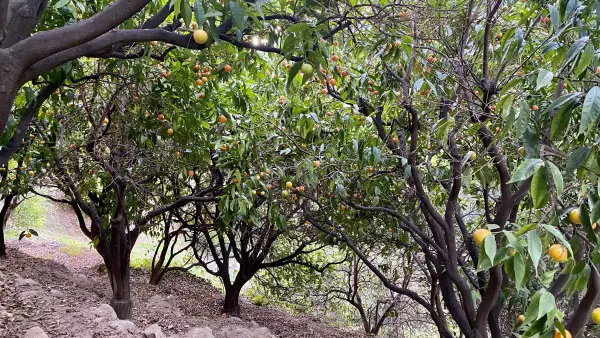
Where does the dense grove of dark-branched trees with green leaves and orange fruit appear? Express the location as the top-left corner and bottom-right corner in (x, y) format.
(0, 0), (600, 338)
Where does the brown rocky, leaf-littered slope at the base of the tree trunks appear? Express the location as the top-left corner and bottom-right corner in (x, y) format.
(0, 247), (362, 338)
